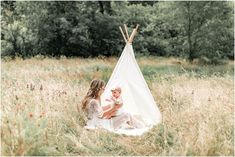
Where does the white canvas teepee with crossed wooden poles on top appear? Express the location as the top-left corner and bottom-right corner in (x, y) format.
(101, 25), (161, 126)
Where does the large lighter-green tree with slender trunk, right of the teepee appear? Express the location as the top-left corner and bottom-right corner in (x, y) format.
(146, 1), (234, 63)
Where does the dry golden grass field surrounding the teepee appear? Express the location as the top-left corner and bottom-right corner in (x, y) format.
(1, 57), (234, 156)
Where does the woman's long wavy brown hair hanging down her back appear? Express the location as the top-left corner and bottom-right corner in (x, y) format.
(82, 79), (105, 110)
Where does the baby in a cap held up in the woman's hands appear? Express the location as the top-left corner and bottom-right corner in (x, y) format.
(105, 86), (123, 119)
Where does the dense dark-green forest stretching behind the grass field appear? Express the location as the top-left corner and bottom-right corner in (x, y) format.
(1, 1), (234, 64)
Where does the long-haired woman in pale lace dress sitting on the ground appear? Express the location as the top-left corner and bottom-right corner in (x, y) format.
(82, 79), (143, 130)
